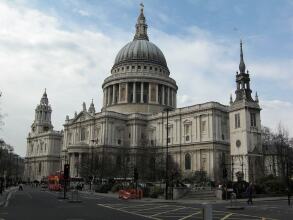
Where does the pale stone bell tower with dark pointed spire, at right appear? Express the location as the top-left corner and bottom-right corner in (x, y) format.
(229, 41), (263, 182)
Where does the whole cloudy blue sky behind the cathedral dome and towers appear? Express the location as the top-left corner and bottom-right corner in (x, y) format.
(0, 0), (293, 156)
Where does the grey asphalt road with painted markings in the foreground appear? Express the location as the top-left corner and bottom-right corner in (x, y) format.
(0, 186), (293, 220)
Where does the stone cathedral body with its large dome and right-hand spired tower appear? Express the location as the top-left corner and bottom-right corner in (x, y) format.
(62, 8), (261, 181)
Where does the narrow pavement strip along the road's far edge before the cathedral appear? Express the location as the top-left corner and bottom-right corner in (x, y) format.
(82, 191), (287, 204)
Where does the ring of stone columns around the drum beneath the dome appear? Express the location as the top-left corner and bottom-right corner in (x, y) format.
(103, 82), (176, 108)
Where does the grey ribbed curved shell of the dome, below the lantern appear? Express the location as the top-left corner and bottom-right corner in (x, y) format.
(113, 39), (168, 68)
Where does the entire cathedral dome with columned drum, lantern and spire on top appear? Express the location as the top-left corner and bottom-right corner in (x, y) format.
(102, 4), (178, 114)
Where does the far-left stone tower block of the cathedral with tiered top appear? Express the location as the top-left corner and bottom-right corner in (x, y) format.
(24, 91), (63, 181)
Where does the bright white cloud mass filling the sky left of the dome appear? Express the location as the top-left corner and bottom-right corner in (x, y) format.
(0, 2), (123, 155)
